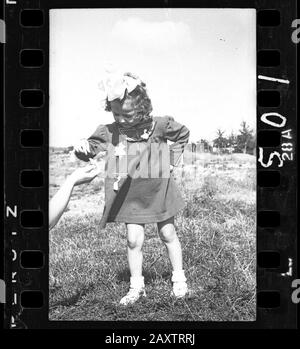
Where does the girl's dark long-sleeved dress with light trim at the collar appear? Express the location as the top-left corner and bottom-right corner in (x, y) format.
(76, 116), (189, 227)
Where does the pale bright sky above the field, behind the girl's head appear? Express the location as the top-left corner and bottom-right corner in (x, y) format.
(50, 8), (256, 146)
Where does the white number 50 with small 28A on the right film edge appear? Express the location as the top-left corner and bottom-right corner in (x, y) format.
(258, 113), (294, 168)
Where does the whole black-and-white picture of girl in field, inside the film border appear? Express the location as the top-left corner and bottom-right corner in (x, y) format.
(49, 8), (257, 322)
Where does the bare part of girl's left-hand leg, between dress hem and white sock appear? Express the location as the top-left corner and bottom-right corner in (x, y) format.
(126, 224), (145, 277)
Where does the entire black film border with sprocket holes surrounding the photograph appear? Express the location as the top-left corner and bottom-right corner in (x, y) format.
(4, 1), (297, 328)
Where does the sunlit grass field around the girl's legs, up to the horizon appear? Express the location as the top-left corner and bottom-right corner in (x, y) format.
(49, 152), (256, 321)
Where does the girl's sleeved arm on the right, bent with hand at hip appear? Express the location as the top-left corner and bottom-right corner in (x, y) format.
(165, 116), (190, 166)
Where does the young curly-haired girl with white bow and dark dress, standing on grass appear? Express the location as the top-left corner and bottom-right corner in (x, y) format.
(75, 73), (189, 305)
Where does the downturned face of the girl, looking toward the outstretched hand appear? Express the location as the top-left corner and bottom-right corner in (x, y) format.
(110, 94), (140, 128)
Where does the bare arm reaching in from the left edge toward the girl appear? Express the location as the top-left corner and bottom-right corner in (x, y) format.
(49, 165), (100, 229)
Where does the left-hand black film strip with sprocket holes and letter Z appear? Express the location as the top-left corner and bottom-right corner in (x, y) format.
(4, 1), (49, 328)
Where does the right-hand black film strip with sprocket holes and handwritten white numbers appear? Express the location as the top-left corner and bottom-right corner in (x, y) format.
(257, 4), (297, 328)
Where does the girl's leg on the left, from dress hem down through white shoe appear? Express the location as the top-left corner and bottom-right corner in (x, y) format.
(120, 224), (146, 305)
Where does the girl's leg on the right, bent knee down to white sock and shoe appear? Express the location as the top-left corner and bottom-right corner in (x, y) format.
(157, 217), (188, 298)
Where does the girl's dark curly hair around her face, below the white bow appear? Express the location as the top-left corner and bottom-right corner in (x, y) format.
(104, 73), (152, 117)
